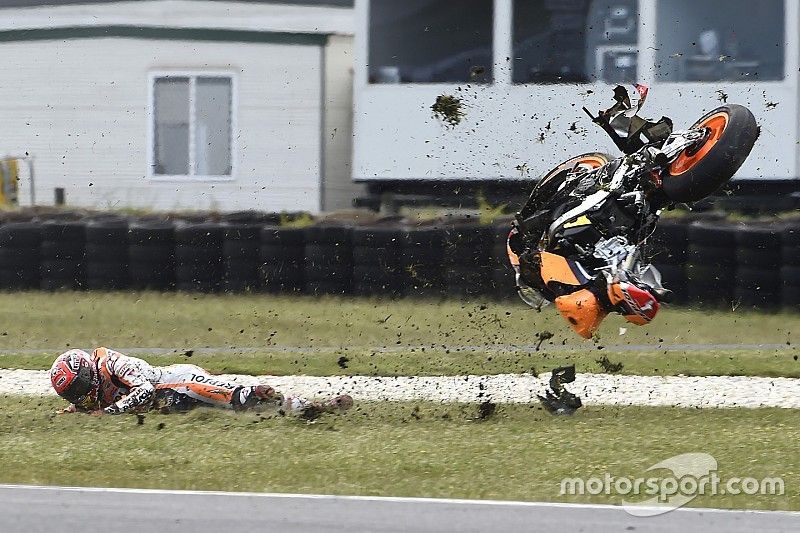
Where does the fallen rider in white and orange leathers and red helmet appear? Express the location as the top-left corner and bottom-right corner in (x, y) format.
(50, 348), (353, 418)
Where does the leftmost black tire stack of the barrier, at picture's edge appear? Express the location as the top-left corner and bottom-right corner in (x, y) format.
(0, 222), (42, 290)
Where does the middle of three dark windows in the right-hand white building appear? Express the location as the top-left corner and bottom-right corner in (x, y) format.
(513, 0), (639, 83)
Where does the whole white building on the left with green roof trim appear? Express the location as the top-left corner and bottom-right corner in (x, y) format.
(0, 0), (355, 212)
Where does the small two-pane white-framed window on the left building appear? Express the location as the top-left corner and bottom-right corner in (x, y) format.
(150, 74), (233, 177)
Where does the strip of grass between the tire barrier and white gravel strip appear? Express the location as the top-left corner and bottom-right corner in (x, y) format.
(0, 292), (800, 377)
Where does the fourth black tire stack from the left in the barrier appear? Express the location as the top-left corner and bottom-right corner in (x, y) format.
(127, 221), (175, 291)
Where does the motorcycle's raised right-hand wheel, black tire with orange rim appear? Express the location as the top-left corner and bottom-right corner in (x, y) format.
(663, 104), (759, 202)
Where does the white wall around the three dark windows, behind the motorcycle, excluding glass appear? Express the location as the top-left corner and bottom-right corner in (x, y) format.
(353, 0), (800, 180)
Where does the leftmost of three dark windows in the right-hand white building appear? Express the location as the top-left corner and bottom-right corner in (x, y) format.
(369, 0), (493, 83)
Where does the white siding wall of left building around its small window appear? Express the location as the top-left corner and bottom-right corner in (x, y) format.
(0, 38), (322, 211)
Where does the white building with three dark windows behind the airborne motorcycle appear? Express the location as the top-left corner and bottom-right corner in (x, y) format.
(353, 0), (800, 189)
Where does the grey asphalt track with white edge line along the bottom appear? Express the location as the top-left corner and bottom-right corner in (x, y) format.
(0, 485), (800, 533)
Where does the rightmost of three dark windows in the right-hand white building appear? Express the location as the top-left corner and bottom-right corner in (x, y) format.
(656, 0), (785, 81)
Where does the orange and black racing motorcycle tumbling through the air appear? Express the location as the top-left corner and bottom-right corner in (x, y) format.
(508, 85), (759, 338)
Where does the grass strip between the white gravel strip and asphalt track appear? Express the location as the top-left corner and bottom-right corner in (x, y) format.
(0, 397), (800, 510)
